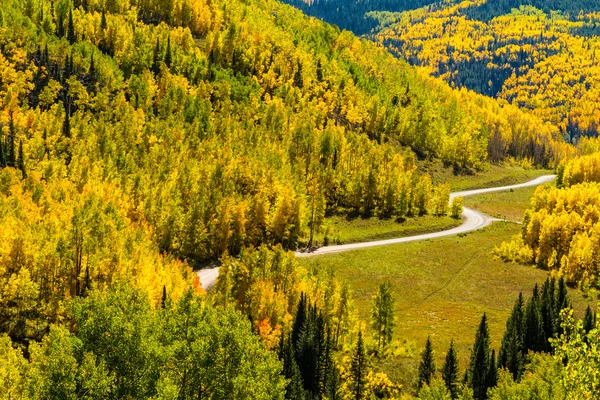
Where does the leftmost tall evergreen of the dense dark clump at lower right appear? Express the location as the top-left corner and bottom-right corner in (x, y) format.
(498, 293), (524, 381)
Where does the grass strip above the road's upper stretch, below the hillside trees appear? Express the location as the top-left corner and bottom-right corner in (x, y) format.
(420, 162), (553, 192)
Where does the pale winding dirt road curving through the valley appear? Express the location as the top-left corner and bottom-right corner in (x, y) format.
(198, 175), (556, 290)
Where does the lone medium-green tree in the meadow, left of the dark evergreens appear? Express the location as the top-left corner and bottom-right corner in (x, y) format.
(371, 281), (395, 350)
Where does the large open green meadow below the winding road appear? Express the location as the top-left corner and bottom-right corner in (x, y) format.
(301, 223), (588, 391)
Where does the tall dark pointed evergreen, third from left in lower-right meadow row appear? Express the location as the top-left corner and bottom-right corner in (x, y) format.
(468, 314), (495, 400)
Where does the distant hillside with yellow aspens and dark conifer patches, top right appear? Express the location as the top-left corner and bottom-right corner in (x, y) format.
(377, 0), (600, 140)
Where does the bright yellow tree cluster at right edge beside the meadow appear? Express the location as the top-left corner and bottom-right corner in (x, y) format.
(496, 153), (600, 287)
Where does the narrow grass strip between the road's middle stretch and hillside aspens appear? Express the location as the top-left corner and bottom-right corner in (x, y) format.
(316, 215), (461, 244)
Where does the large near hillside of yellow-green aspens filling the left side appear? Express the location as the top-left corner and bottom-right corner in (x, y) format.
(0, 0), (592, 399)
